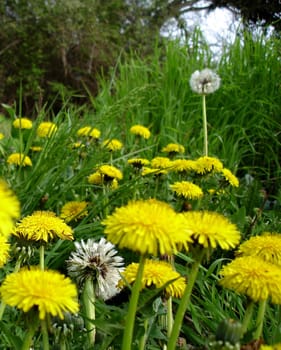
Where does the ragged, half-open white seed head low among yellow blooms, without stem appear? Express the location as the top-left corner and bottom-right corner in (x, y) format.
(67, 238), (124, 300)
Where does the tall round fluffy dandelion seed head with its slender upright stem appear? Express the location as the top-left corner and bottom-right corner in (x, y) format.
(189, 68), (221, 156)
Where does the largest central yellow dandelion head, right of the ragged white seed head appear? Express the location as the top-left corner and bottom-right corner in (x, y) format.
(102, 199), (191, 256)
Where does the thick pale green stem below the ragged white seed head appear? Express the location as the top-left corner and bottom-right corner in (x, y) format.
(82, 278), (96, 347)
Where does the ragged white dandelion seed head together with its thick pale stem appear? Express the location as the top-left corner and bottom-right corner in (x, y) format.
(67, 238), (124, 346)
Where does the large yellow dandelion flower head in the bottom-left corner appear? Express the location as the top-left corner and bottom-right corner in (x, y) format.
(0, 268), (79, 320)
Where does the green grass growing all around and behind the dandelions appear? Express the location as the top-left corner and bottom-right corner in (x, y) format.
(0, 32), (281, 350)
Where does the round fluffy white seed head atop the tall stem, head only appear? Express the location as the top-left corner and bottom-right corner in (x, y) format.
(189, 68), (221, 95)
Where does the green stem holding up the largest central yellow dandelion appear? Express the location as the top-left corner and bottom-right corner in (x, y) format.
(122, 255), (145, 350)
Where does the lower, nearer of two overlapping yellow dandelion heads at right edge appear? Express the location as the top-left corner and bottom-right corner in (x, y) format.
(220, 256), (281, 304)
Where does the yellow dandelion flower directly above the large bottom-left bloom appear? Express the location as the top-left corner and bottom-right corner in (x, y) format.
(13, 211), (73, 242)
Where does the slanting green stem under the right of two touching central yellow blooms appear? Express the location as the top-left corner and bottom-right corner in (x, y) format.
(167, 249), (205, 350)
